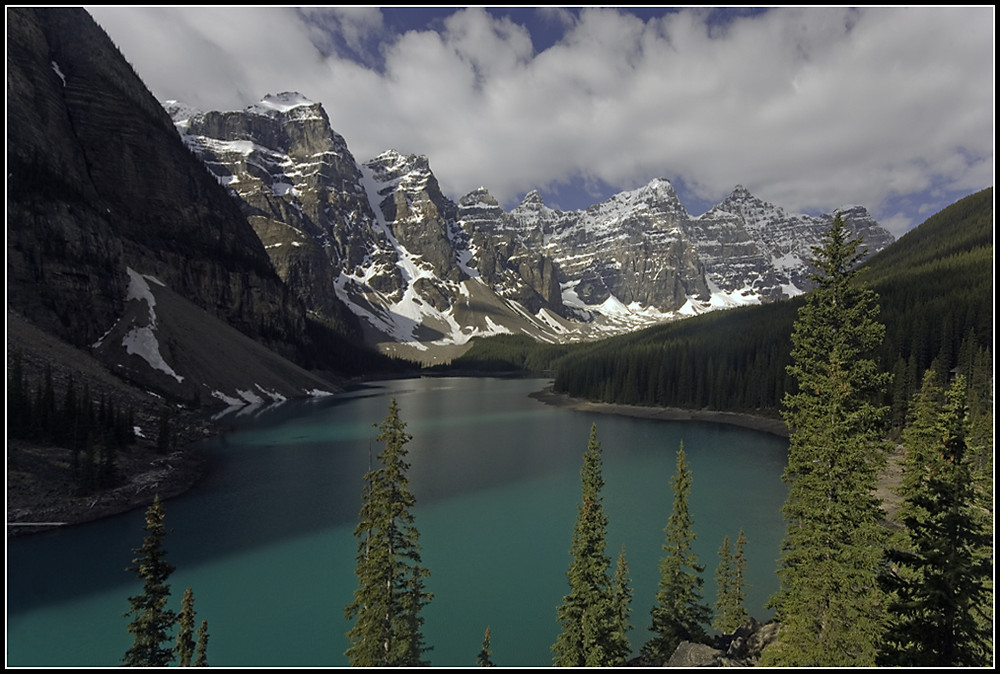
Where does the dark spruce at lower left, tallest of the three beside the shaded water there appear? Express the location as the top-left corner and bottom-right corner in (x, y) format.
(122, 496), (177, 667)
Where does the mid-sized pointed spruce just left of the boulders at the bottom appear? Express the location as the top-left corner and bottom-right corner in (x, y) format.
(642, 444), (711, 664)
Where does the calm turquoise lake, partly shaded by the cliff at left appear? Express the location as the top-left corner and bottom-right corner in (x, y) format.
(7, 378), (788, 667)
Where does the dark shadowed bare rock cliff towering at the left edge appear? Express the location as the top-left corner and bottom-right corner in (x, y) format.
(7, 8), (352, 399)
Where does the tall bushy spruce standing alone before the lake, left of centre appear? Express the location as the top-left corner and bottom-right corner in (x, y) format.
(344, 399), (431, 667)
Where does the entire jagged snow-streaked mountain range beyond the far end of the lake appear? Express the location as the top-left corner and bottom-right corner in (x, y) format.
(164, 92), (892, 361)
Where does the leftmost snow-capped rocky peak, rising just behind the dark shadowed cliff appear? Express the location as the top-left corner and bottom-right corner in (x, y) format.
(167, 95), (376, 333)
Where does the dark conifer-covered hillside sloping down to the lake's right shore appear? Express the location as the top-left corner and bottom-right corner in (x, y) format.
(454, 188), (993, 425)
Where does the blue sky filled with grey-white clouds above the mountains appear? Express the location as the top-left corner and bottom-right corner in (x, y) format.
(88, 6), (995, 235)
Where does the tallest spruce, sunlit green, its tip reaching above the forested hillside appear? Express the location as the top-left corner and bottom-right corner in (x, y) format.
(762, 213), (888, 666)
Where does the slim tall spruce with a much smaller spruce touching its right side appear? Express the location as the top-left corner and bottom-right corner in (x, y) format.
(552, 425), (628, 667)
